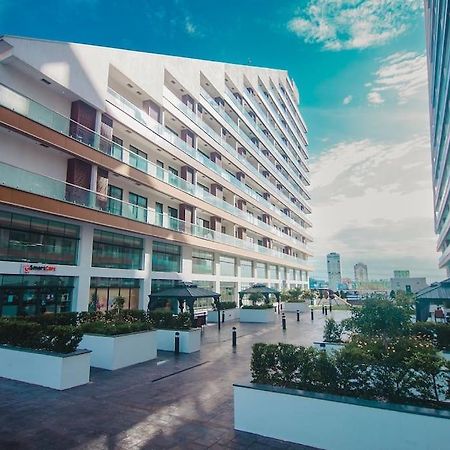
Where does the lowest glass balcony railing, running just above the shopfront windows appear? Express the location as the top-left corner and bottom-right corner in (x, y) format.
(0, 163), (310, 264)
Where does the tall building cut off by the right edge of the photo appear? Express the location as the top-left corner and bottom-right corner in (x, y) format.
(425, 0), (450, 276)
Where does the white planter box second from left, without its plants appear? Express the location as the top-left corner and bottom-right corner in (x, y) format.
(80, 331), (156, 370)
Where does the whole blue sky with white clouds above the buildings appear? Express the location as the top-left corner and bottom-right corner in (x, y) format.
(0, 0), (444, 281)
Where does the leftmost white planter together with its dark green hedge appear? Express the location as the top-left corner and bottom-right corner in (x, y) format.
(0, 315), (91, 390)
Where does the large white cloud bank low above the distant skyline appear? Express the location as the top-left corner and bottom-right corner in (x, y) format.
(311, 136), (444, 279)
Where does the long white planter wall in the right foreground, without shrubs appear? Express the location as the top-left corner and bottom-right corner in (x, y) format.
(234, 383), (450, 450)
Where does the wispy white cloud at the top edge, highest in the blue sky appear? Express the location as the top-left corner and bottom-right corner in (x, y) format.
(288, 0), (423, 51)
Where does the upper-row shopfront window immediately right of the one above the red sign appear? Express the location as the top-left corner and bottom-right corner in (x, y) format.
(92, 230), (144, 269)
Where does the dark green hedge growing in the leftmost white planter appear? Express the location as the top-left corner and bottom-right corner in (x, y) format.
(0, 319), (82, 353)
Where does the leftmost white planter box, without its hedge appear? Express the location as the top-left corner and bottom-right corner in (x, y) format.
(0, 346), (91, 390)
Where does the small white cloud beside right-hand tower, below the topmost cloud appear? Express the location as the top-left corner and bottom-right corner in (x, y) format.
(368, 52), (428, 104)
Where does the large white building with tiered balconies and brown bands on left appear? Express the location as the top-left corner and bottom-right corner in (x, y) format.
(0, 36), (311, 315)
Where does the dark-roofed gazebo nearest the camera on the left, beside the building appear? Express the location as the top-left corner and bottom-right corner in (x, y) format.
(148, 281), (220, 326)
